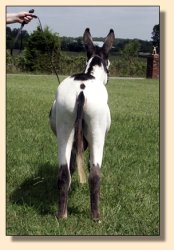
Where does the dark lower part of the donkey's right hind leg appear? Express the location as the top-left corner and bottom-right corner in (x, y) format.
(89, 165), (100, 221)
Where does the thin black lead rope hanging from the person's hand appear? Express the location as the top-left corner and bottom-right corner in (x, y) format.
(11, 9), (60, 84)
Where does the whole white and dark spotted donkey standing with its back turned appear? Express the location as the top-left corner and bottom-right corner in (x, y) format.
(50, 28), (115, 221)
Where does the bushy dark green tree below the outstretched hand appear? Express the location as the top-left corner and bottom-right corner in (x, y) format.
(25, 27), (60, 73)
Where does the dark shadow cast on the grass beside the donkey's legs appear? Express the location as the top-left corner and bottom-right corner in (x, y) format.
(10, 162), (82, 215)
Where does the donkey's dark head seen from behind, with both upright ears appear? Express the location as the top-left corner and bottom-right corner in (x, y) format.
(83, 28), (115, 67)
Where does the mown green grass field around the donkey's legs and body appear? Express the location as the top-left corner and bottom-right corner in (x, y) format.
(6, 75), (159, 236)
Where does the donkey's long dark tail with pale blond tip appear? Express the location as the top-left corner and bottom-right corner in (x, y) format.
(74, 91), (86, 183)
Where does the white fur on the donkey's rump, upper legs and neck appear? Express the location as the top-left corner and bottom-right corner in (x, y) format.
(50, 59), (111, 173)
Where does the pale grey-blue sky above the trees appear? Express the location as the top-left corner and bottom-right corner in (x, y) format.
(6, 6), (160, 41)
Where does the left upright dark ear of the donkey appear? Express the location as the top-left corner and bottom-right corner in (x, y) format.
(83, 28), (95, 59)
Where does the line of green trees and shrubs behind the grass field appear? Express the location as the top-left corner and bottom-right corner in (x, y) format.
(6, 25), (159, 76)
